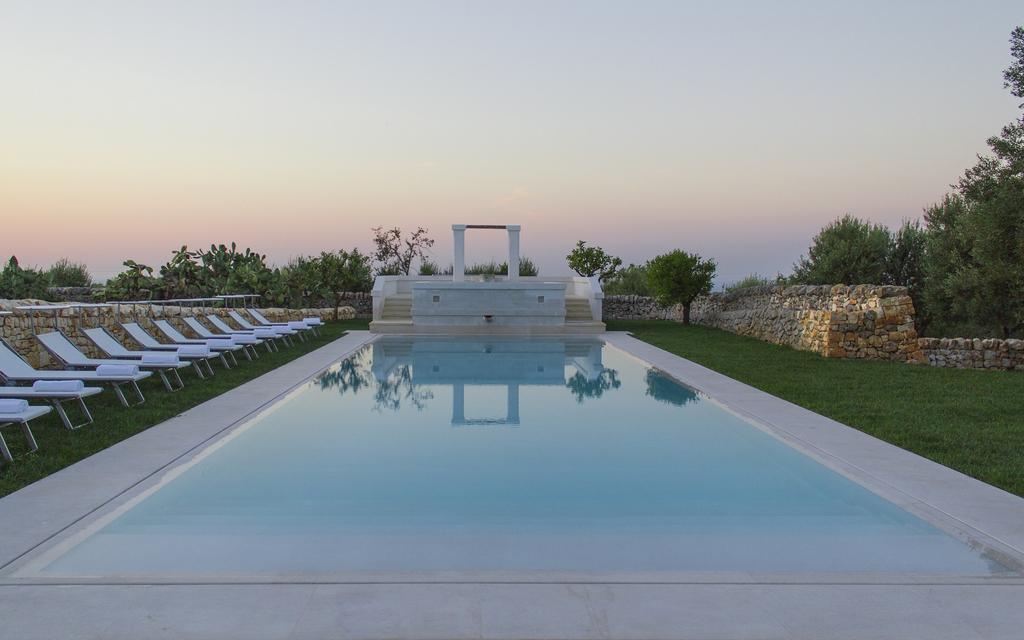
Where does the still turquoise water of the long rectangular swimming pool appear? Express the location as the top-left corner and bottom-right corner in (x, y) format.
(41, 339), (1001, 575)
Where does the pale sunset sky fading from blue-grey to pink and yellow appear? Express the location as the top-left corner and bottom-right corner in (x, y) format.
(0, 0), (1024, 284)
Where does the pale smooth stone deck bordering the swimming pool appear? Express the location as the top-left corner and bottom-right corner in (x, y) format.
(0, 332), (1024, 640)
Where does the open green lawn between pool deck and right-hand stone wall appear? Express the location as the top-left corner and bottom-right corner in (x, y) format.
(608, 321), (1024, 496)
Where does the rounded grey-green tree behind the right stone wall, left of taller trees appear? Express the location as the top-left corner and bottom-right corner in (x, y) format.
(794, 214), (891, 285)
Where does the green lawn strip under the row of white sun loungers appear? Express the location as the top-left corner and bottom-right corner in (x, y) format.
(0, 321), (367, 496)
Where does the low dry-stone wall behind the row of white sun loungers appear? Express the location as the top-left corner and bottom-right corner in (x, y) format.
(0, 300), (355, 368)
